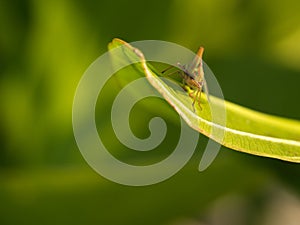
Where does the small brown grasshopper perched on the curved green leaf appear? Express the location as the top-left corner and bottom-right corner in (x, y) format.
(161, 47), (209, 112)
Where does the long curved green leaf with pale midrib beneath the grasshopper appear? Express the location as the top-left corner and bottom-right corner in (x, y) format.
(109, 39), (300, 163)
